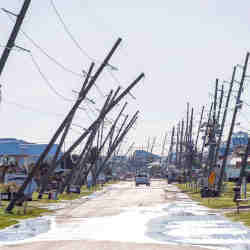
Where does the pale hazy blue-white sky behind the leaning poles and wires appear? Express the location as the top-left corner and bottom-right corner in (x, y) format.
(0, 0), (250, 152)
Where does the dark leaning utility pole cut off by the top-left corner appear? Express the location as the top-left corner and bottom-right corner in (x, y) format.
(0, 0), (31, 76)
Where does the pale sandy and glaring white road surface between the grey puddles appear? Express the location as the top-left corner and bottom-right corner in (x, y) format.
(1, 180), (209, 250)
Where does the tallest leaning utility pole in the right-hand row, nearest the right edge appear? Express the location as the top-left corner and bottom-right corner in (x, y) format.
(218, 52), (249, 195)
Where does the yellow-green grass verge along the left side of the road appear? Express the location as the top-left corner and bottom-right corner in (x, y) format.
(0, 181), (117, 229)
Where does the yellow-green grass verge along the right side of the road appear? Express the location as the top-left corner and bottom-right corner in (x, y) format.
(177, 182), (250, 226)
